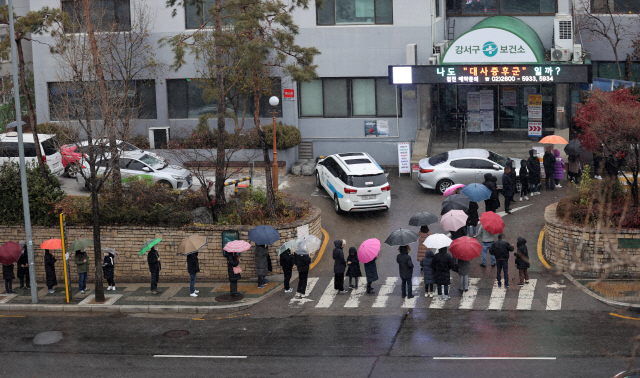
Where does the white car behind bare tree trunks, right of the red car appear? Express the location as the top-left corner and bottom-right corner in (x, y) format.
(76, 151), (193, 190)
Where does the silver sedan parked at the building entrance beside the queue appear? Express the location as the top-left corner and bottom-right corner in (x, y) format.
(418, 148), (522, 194)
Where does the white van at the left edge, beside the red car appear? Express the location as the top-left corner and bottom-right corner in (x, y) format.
(0, 131), (64, 176)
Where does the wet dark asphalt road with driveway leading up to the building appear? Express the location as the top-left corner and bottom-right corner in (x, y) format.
(0, 175), (640, 378)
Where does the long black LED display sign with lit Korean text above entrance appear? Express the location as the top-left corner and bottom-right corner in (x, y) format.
(389, 64), (592, 84)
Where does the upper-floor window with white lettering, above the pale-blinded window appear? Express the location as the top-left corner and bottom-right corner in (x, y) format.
(316, 0), (393, 25)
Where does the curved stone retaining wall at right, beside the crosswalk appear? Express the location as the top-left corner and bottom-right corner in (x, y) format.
(544, 203), (640, 278)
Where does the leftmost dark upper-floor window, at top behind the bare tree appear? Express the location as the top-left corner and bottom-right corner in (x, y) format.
(62, 0), (131, 33)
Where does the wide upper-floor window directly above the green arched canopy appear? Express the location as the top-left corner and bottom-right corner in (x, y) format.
(447, 0), (556, 16)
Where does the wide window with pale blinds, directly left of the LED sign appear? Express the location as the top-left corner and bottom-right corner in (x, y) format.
(299, 78), (402, 118)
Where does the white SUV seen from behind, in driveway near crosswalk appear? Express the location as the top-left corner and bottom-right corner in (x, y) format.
(316, 152), (391, 214)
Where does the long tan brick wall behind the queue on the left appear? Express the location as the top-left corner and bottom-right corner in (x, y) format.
(0, 207), (322, 284)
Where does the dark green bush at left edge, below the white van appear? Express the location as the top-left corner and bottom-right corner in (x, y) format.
(0, 163), (65, 226)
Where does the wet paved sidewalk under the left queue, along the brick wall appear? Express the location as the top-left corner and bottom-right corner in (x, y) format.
(0, 272), (298, 314)
